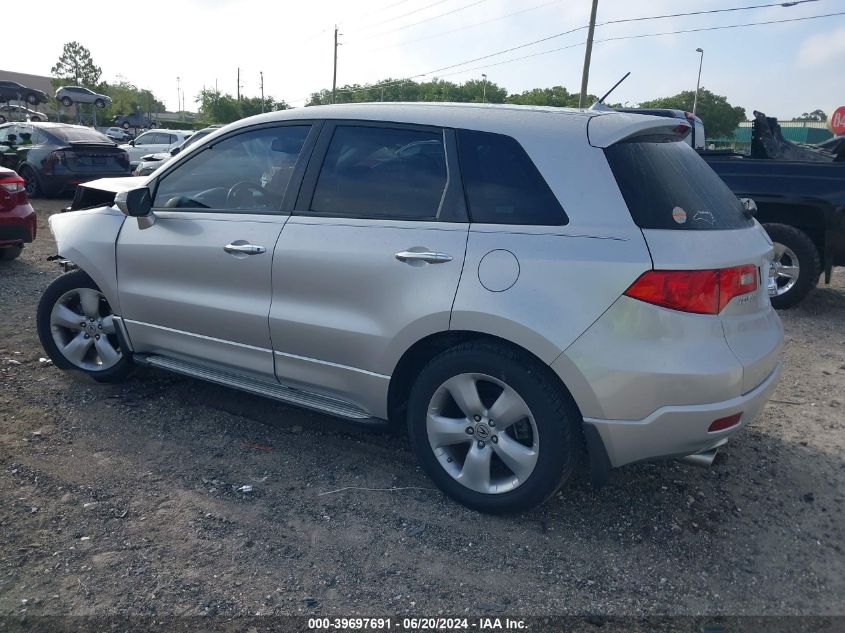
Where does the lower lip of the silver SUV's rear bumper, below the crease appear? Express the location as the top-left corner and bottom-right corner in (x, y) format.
(584, 363), (782, 468)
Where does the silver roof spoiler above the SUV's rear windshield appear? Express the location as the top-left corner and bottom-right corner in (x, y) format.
(587, 112), (692, 148)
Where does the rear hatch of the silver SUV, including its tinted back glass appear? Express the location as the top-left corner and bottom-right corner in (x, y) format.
(605, 117), (783, 393)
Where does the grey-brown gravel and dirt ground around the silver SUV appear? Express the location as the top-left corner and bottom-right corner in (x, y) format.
(0, 200), (845, 616)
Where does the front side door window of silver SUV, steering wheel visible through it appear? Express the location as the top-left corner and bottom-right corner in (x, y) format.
(153, 125), (311, 212)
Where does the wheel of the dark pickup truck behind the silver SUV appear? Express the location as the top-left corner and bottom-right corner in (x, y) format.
(763, 224), (821, 309)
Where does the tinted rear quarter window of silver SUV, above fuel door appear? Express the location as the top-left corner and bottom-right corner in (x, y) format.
(458, 130), (569, 226)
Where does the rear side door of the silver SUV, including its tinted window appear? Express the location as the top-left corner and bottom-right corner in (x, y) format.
(270, 122), (469, 417)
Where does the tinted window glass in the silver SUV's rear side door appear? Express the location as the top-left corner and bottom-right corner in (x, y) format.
(311, 126), (446, 220)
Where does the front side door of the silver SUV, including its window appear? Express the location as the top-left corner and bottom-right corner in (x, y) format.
(117, 123), (312, 380)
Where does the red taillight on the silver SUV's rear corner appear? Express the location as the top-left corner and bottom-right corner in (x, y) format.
(625, 264), (757, 314)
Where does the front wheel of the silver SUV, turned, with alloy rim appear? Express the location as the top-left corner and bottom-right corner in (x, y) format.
(36, 270), (133, 382)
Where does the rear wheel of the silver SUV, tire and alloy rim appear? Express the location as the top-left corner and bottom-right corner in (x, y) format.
(408, 342), (583, 514)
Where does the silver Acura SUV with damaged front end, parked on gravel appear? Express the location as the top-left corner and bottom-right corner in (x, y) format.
(37, 104), (783, 512)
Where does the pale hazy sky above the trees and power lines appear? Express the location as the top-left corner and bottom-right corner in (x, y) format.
(11, 0), (845, 118)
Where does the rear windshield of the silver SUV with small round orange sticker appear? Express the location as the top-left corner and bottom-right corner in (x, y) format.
(604, 142), (754, 231)
